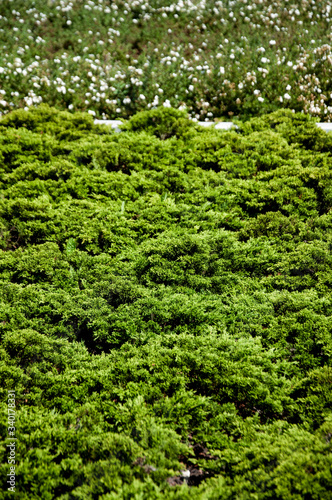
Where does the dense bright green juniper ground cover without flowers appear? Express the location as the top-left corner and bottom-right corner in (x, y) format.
(0, 105), (332, 500)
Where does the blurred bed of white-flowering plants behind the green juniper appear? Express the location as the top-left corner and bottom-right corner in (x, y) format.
(0, 0), (332, 121)
